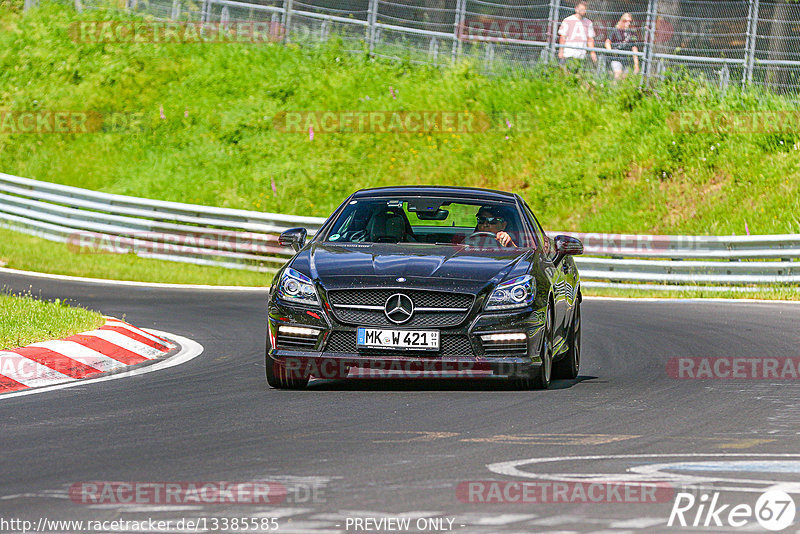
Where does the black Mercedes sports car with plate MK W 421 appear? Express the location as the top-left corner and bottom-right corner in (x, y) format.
(266, 187), (583, 389)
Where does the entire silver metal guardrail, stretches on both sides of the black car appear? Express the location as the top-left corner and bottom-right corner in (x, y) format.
(0, 174), (800, 285)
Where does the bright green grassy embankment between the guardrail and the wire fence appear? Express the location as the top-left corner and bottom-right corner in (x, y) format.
(0, 5), (800, 298)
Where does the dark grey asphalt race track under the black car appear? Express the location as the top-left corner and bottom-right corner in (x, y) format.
(0, 274), (800, 533)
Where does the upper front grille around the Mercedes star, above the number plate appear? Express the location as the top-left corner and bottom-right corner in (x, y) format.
(328, 289), (475, 328)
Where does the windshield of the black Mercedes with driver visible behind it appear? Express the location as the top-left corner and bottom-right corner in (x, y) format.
(323, 197), (535, 248)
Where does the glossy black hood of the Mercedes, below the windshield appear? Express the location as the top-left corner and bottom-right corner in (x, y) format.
(292, 243), (532, 289)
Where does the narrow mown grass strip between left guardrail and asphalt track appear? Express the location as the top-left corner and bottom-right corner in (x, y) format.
(0, 229), (272, 287)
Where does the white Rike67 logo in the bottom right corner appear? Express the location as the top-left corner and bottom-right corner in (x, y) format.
(667, 489), (797, 532)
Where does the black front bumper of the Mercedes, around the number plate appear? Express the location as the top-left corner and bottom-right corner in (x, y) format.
(267, 298), (546, 378)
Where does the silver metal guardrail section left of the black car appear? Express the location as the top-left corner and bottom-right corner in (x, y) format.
(0, 174), (324, 271)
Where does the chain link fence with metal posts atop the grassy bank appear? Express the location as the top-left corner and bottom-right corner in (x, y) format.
(34, 0), (800, 93)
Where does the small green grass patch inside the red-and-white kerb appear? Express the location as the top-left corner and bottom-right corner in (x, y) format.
(0, 293), (104, 350)
